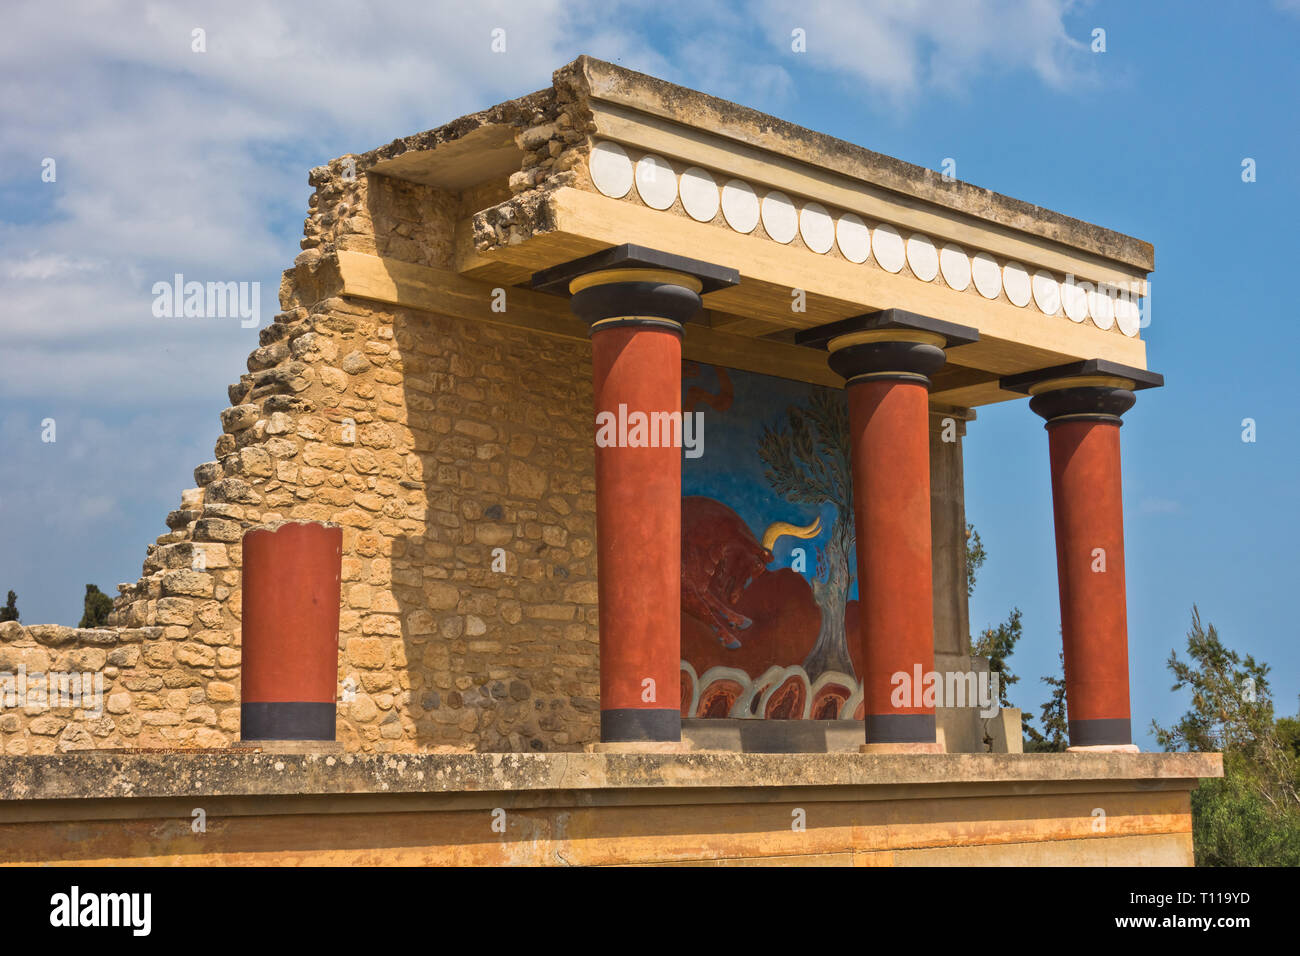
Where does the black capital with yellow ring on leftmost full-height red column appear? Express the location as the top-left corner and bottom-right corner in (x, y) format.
(532, 243), (740, 334)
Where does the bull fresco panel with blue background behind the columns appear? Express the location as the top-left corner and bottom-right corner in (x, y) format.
(681, 362), (862, 719)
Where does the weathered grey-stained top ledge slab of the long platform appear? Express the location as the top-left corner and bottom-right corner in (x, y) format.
(0, 752), (1223, 801)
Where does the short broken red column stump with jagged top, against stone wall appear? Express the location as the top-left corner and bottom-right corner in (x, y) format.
(239, 522), (343, 740)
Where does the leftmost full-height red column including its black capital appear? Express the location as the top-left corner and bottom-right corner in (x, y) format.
(533, 251), (740, 749)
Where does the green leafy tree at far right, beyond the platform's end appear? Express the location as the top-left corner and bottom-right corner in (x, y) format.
(1152, 606), (1300, 866)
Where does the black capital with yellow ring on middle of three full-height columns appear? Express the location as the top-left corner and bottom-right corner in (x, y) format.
(794, 308), (979, 388)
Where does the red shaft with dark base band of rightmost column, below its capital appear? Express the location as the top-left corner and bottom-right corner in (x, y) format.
(1048, 419), (1132, 747)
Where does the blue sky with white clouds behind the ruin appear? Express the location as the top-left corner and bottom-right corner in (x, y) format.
(0, 0), (1300, 745)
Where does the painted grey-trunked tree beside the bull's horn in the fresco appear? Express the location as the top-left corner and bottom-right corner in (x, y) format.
(758, 389), (853, 680)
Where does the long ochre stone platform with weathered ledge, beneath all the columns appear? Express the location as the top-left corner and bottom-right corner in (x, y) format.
(0, 750), (1223, 866)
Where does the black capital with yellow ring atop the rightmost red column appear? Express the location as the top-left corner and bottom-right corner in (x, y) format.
(1000, 359), (1165, 428)
